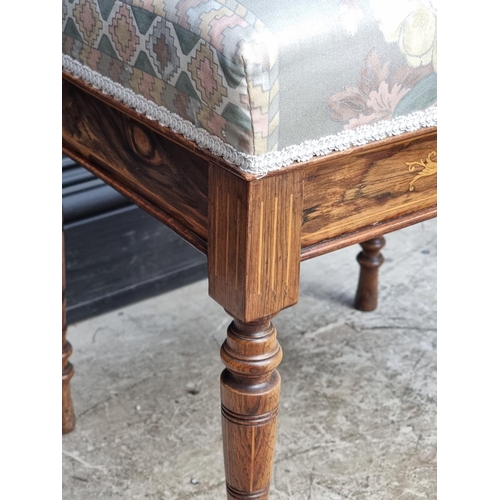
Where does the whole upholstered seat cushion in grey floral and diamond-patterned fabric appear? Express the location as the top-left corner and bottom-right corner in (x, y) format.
(63, 0), (437, 168)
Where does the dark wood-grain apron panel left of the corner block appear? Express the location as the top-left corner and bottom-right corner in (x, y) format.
(63, 79), (208, 241)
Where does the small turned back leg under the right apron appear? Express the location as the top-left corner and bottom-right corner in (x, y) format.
(354, 236), (385, 311)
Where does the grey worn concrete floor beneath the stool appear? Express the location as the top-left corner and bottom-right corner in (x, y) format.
(63, 220), (436, 500)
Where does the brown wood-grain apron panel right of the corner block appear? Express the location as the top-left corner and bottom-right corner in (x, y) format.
(302, 129), (437, 248)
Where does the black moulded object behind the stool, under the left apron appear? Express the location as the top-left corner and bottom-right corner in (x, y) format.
(62, 156), (207, 324)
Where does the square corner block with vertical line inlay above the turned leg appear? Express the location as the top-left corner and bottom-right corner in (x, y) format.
(208, 165), (302, 321)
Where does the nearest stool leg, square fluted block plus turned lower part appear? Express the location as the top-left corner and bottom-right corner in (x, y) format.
(208, 165), (303, 500)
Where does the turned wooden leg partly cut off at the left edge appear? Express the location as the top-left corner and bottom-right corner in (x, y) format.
(62, 223), (75, 434)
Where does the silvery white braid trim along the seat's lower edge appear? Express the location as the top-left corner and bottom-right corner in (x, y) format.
(62, 54), (437, 177)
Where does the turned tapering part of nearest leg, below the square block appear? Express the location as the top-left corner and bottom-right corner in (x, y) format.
(221, 320), (282, 500)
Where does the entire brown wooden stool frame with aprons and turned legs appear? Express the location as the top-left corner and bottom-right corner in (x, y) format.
(63, 72), (437, 500)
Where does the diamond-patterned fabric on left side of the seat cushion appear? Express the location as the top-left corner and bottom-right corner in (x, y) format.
(63, 0), (277, 153)
